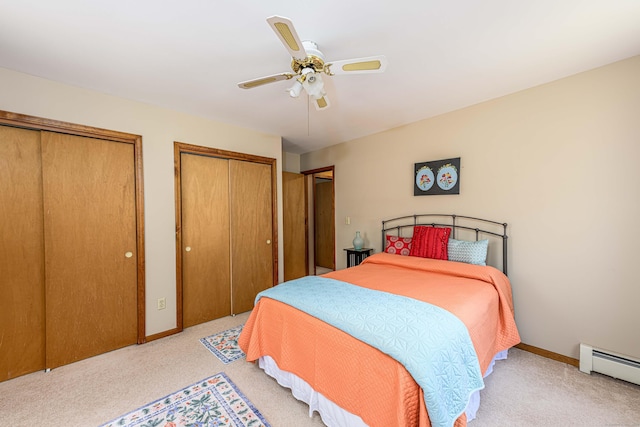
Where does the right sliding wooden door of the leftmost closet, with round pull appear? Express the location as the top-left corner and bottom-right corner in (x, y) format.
(42, 132), (137, 368)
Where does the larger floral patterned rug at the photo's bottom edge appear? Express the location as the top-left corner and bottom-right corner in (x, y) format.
(101, 372), (270, 427)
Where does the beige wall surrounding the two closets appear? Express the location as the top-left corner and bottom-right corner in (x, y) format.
(0, 68), (283, 335)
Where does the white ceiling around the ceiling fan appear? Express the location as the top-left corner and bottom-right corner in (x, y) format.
(0, 0), (640, 153)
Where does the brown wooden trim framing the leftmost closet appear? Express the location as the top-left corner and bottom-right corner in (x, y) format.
(0, 110), (147, 344)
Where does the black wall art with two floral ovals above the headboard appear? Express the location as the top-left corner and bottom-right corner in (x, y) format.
(413, 157), (460, 196)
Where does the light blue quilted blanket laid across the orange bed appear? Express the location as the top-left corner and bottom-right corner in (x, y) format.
(256, 276), (484, 427)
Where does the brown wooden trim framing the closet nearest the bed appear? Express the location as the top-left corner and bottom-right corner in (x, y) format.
(172, 141), (278, 336)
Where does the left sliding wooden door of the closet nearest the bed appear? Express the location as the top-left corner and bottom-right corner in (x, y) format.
(180, 153), (231, 327)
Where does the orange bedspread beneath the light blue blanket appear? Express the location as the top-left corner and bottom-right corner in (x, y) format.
(238, 253), (520, 426)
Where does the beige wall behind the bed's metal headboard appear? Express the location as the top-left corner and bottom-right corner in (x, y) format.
(301, 57), (640, 358)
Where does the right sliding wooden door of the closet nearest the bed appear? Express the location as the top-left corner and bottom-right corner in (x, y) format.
(229, 160), (274, 314)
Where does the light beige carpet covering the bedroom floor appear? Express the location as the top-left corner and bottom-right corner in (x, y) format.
(0, 313), (640, 427)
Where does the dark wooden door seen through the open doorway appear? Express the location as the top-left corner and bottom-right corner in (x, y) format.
(315, 181), (335, 270)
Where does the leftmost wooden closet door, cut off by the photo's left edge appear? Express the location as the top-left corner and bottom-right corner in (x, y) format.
(0, 126), (45, 381)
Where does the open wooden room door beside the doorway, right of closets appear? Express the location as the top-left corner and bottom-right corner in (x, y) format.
(282, 172), (308, 281)
